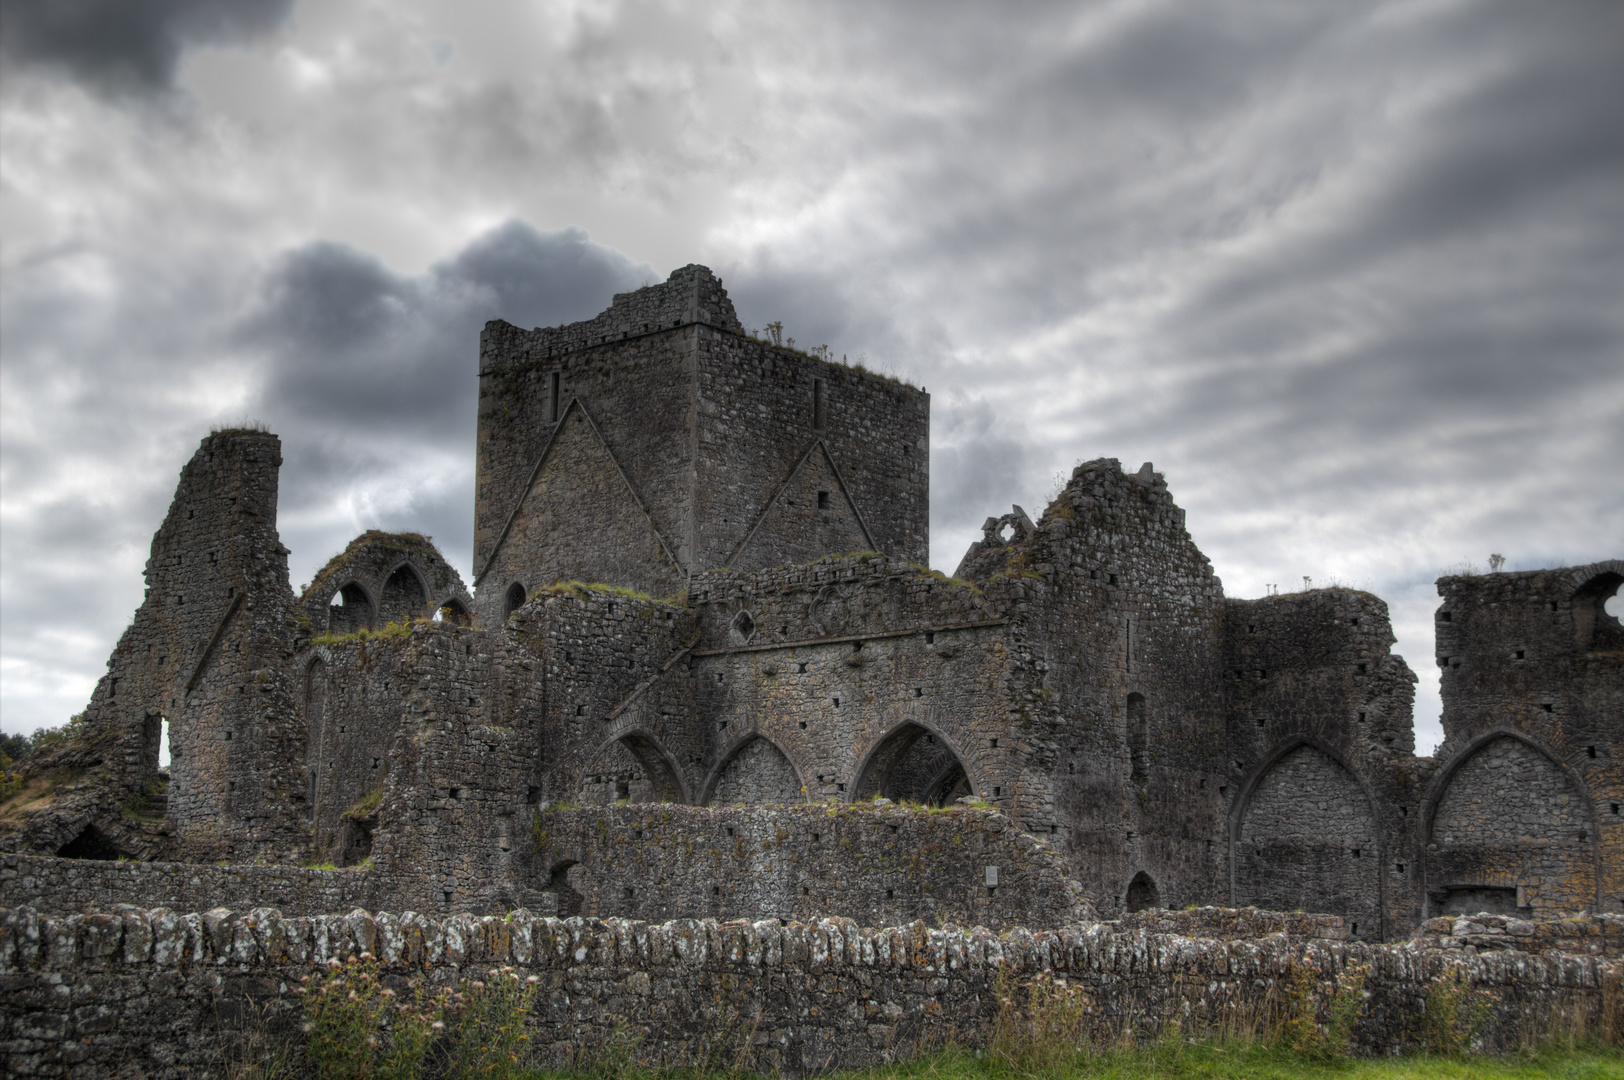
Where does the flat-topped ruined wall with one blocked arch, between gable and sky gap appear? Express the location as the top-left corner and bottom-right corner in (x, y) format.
(1223, 588), (1431, 937)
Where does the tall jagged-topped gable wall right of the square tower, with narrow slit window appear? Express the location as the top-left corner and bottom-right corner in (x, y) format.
(960, 458), (1228, 914)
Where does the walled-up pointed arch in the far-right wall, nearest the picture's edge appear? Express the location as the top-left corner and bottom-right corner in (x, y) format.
(1421, 728), (1601, 916)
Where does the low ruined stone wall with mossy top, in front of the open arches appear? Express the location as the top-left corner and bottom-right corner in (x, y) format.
(528, 804), (1095, 929)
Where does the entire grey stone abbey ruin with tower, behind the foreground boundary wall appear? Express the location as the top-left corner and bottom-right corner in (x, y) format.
(0, 266), (1624, 1071)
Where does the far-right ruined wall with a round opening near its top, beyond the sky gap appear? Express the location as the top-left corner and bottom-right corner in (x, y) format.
(1442, 560), (1624, 911)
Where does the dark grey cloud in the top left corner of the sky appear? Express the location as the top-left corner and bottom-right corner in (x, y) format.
(0, 0), (294, 91)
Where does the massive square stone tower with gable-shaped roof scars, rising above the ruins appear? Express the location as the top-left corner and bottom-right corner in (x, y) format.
(474, 265), (931, 625)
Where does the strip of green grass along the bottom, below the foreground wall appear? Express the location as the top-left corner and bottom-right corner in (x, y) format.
(500, 1039), (1624, 1080)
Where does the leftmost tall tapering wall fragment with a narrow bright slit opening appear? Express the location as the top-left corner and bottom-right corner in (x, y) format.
(3, 430), (305, 861)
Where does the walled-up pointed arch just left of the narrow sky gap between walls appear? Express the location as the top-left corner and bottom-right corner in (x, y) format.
(1229, 736), (1387, 937)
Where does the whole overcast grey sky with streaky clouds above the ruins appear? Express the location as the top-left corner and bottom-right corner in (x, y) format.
(0, 0), (1624, 752)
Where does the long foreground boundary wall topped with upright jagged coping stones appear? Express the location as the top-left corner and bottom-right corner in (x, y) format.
(0, 909), (1621, 1080)
